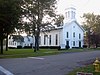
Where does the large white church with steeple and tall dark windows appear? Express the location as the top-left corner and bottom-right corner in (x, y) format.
(40, 7), (84, 48)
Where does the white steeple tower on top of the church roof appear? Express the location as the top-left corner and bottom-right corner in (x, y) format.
(65, 7), (76, 21)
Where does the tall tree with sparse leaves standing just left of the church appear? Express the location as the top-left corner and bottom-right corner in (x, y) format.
(22, 0), (56, 52)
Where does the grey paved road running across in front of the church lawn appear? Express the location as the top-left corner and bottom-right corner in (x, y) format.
(0, 51), (100, 75)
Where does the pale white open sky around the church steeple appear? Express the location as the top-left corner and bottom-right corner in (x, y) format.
(57, 0), (100, 24)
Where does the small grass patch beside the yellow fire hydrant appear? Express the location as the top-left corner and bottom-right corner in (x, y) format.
(67, 64), (100, 75)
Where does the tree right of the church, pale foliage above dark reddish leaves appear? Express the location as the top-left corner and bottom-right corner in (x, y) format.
(83, 13), (100, 47)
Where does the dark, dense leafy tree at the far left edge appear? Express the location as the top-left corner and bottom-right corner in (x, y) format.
(0, 0), (22, 54)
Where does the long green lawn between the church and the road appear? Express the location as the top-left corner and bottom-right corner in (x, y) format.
(0, 49), (84, 58)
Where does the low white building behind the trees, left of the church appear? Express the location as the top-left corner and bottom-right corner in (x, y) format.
(8, 35), (33, 48)
